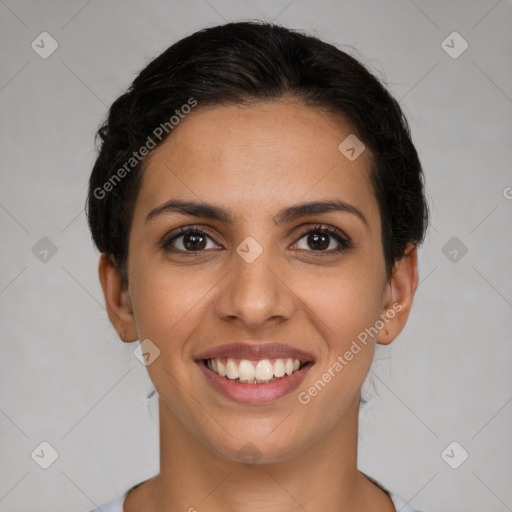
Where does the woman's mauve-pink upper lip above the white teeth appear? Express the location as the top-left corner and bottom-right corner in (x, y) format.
(195, 341), (315, 362)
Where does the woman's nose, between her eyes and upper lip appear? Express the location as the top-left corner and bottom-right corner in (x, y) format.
(215, 244), (296, 331)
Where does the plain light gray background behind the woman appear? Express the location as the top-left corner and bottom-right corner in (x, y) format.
(0, 0), (512, 512)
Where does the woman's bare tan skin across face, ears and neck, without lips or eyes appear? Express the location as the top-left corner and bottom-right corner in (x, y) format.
(99, 100), (418, 512)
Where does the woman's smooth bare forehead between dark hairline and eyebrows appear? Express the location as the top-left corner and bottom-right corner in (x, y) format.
(137, 101), (375, 220)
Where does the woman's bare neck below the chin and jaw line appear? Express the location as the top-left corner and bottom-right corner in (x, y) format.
(142, 398), (382, 512)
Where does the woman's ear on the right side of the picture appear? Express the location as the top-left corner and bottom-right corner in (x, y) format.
(377, 242), (418, 345)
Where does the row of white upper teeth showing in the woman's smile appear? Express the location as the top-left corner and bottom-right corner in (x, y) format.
(207, 357), (301, 382)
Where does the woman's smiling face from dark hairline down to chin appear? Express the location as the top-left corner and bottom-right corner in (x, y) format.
(102, 101), (414, 461)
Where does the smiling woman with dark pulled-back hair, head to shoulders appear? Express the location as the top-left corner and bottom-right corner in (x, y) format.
(88, 22), (428, 512)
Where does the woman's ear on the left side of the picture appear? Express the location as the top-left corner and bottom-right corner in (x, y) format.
(98, 253), (138, 342)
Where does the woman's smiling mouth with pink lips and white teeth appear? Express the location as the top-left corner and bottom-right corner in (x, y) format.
(195, 342), (315, 403)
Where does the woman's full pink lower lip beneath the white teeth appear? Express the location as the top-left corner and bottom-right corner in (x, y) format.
(197, 360), (313, 404)
